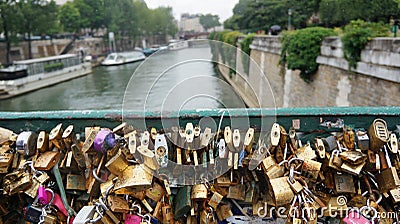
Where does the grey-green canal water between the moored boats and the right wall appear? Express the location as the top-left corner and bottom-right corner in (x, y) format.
(0, 46), (244, 111)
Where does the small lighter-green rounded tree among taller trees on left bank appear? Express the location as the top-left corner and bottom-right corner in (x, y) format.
(58, 2), (81, 33)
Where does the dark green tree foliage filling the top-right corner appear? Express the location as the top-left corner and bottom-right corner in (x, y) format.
(319, 0), (400, 27)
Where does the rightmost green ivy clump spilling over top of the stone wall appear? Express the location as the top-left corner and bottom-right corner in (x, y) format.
(342, 20), (390, 69)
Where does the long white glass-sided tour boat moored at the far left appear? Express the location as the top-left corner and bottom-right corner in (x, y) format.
(0, 54), (92, 99)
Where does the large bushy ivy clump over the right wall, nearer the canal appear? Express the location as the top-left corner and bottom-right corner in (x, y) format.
(280, 27), (335, 82)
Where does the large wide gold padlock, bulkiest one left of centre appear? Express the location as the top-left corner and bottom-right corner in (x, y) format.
(114, 165), (153, 192)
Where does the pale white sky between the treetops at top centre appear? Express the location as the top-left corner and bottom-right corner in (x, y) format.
(145, 0), (239, 23)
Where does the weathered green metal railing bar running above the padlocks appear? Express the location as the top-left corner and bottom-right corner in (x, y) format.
(0, 107), (400, 132)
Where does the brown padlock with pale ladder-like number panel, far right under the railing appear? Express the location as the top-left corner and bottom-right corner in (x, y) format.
(368, 118), (389, 152)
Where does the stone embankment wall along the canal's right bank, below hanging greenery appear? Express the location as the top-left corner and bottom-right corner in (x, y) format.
(219, 36), (400, 107)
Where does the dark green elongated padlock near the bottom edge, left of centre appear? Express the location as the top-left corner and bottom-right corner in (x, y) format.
(174, 185), (192, 220)
